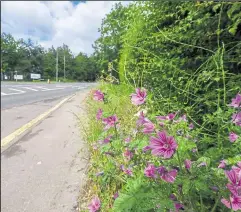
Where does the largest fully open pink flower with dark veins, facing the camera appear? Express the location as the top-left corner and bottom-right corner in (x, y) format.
(149, 131), (177, 158)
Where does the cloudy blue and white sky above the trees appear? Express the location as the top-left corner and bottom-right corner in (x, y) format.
(1, 1), (129, 55)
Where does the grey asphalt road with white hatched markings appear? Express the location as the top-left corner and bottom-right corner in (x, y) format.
(1, 82), (95, 110)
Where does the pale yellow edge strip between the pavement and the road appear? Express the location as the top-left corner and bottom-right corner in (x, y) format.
(1, 93), (76, 153)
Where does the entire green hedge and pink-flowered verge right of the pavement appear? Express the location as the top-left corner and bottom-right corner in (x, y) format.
(83, 1), (241, 212)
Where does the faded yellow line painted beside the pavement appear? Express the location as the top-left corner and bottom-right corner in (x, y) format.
(1, 95), (74, 148)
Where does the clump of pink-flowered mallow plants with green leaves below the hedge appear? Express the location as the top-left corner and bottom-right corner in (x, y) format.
(89, 88), (241, 212)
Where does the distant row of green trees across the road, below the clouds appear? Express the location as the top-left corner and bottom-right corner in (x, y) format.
(1, 33), (98, 81)
